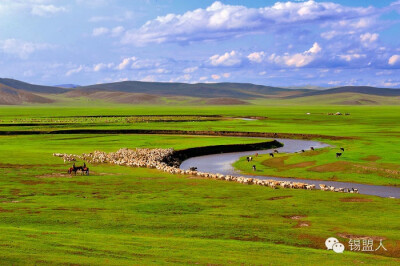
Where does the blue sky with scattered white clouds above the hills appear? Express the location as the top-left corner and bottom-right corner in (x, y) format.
(0, 0), (400, 88)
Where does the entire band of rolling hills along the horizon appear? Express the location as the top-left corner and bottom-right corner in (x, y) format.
(0, 78), (400, 105)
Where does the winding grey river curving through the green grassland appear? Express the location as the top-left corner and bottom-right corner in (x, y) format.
(180, 139), (400, 198)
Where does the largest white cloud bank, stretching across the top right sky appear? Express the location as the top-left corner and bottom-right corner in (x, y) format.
(122, 1), (377, 45)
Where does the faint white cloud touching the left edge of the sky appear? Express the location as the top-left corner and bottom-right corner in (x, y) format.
(0, 39), (54, 59)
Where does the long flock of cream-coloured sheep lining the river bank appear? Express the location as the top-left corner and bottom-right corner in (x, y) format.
(53, 148), (358, 193)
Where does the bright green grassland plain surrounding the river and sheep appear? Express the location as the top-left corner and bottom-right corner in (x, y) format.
(0, 106), (400, 265)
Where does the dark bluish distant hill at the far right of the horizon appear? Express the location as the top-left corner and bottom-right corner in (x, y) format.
(287, 86), (400, 98)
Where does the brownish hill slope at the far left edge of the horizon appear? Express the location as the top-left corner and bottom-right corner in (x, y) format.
(0, 84), (53, 105)
